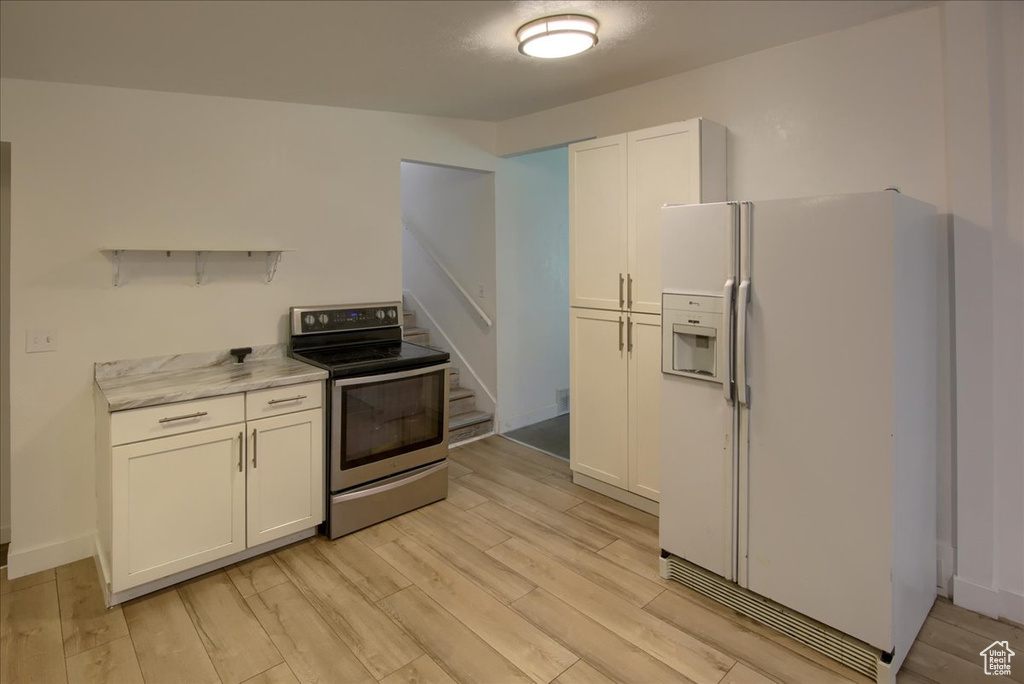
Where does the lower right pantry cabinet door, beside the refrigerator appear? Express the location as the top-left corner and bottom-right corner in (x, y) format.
(627, 313), (662, 501)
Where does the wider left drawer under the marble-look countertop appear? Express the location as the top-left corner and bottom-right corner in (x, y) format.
(111, 394), (246, 445)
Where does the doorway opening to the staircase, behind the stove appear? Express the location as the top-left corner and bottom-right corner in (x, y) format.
(401, 161), (498, 445)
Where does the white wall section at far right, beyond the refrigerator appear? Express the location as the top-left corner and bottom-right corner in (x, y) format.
(943, 2), (1024, 622)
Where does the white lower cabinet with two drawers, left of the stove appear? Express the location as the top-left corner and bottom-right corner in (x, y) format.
(96, 382), (325, 602)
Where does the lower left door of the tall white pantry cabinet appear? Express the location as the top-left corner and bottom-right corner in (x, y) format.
(569, 308), (629, 489)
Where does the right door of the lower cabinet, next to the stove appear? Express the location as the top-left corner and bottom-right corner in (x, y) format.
(247, 409), (325, 547)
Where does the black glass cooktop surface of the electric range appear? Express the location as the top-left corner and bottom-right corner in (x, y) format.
(292, 341), (450, 378)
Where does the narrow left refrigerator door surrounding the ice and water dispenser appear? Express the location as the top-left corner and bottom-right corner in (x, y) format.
(659, 203), (738, 580)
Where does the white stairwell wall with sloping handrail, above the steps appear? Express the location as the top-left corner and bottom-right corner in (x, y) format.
(401, 162), (498, 408)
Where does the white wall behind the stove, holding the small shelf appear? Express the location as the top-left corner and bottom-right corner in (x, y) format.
(0, 80), (497, 576)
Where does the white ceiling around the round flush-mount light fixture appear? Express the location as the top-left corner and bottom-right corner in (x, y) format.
(0, 0), (932, 121)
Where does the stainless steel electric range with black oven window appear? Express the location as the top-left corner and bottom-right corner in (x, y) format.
(289, 302), (451, 539)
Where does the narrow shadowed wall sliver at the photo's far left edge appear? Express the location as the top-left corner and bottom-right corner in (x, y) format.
(0, 142), (10, 544)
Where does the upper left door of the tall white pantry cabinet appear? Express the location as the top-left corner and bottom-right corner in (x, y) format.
(569, 135), (627, 309)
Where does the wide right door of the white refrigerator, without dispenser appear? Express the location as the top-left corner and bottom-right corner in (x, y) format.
(736, 193), (894, 650)
